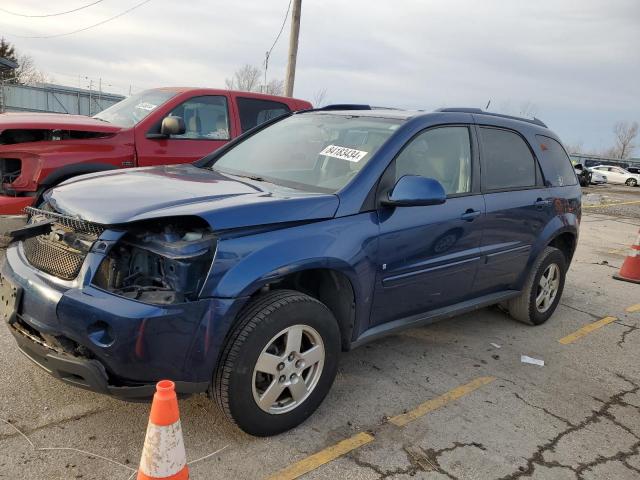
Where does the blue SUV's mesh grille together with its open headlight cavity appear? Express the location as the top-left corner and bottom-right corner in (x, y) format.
(14, 204), (216, 305)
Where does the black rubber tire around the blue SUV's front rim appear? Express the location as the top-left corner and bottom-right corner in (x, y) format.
(211, 290), (340, 437)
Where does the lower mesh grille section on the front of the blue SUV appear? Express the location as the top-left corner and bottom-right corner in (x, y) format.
(22, 235), (85, 280)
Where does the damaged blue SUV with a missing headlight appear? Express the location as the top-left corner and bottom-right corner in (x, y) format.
(0, 108), (581, 435)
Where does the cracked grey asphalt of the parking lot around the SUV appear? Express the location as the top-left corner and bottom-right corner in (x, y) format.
(0, 200), (640, 480)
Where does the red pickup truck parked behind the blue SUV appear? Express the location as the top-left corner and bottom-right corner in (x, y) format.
(0, 88), (311, 215)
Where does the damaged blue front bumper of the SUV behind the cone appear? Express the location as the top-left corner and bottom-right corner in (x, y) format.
(0, 243), (248, 400)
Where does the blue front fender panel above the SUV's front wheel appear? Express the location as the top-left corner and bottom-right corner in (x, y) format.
(203, 213), (378, 316)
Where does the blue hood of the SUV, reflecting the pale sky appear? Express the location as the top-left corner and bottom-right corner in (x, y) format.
(45, 165), (339, 230)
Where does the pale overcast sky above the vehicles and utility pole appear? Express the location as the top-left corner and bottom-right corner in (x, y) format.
(0, 0), (640, 156)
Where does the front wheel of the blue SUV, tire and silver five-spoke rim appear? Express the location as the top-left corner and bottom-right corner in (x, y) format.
(212, 290), (340, 436)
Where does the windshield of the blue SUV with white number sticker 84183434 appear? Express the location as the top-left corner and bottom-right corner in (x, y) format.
(212, 114), (401, 192)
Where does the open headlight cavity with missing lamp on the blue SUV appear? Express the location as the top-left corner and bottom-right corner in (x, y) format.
(93, 221), (216, 304)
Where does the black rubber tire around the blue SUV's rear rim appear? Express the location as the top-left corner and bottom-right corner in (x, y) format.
(506, 247), (567, 325)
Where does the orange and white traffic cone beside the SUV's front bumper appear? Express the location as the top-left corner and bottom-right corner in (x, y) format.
(138, 380), (189, 480)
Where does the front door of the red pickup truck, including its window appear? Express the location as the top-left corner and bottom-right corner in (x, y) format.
(136, 95), (235, 167)
